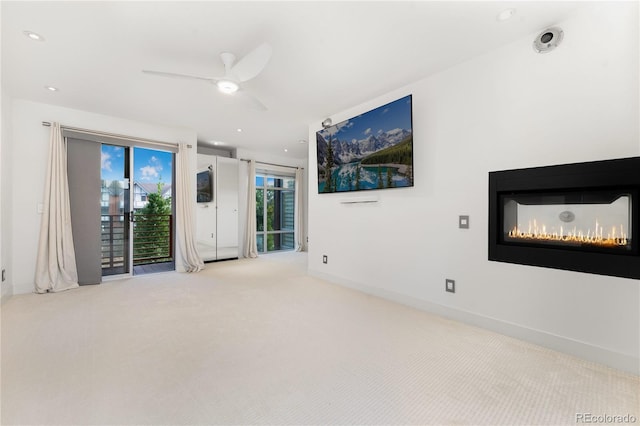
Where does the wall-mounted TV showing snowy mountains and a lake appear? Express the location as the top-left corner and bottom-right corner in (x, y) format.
(316, 95), (413, 193)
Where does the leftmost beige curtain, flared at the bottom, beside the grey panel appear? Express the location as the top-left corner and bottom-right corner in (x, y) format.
(35, 123), (78, 293)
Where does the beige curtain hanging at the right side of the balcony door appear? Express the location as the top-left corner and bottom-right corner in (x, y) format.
(176, 143), (204, 272)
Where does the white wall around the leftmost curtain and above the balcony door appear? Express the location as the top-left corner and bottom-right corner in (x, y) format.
(8, 99), (197, 294)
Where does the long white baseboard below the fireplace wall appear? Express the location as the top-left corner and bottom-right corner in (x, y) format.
(309, 270), (640, 375)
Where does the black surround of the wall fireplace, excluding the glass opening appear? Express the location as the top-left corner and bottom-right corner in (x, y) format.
(489, 157), (640, 279)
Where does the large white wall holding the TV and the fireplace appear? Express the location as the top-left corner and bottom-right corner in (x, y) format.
(308, 2), (640, 373)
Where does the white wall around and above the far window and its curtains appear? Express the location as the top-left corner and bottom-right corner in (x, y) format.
(237, 150), (308, 256)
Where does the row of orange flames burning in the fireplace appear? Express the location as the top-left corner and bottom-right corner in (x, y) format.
(508, 219), (629, 247)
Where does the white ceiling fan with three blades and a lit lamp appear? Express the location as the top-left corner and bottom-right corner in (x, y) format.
(142, 43), (272, 111)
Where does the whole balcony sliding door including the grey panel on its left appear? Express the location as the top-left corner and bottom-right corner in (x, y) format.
(63, 130), (176, 285)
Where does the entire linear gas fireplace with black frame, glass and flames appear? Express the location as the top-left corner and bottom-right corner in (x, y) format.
(489, 157), (640, 279)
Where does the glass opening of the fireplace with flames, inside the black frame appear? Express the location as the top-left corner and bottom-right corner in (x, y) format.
(500, 190), (634, 254)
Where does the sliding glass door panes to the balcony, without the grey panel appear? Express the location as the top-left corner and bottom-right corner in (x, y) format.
(100, 144), (175, 276)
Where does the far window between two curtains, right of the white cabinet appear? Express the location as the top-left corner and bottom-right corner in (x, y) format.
(256, 172), (295, 253)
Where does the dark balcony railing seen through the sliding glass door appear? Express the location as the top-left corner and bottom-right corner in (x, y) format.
(101, 213), (173, 274)
